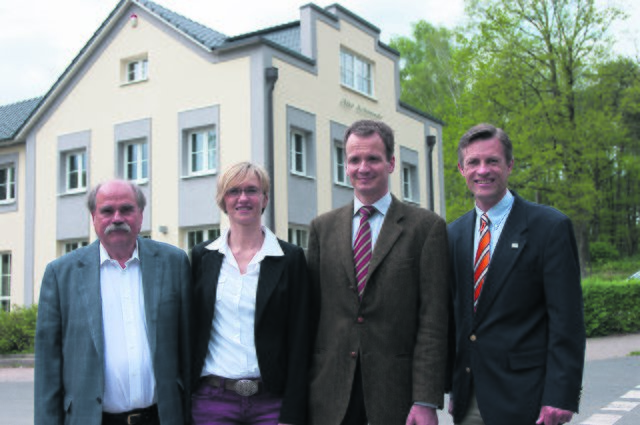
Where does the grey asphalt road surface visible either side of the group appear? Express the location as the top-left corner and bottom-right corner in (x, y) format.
(0, 333), (640, 425)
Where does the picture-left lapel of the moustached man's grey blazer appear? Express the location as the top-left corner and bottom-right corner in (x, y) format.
(75, 241), (104, 363)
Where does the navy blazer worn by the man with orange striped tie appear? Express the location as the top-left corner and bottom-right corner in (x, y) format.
(448, 193), (585, 425)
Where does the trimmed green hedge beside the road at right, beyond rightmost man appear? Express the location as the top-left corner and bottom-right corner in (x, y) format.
(582, 279), (640, 337)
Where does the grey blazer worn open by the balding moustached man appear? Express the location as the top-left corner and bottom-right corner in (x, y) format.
(34, 238), (191, 425)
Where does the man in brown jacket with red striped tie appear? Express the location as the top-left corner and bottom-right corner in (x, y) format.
(308, 120), (448, 425)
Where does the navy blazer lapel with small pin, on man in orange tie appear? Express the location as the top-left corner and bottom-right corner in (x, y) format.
(471, 194), (527, 321)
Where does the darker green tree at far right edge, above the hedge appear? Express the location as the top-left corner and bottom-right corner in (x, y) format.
(580, 58), (640, 256)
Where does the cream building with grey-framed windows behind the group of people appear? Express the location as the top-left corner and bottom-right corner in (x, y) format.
(0, 0), (445, 304)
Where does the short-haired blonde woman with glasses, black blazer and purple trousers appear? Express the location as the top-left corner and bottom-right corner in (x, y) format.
(191, 162), (309, 425)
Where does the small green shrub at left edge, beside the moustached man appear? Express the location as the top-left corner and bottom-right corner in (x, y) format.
(0, 305), (38, 354)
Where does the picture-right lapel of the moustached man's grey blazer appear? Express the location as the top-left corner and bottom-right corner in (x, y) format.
(138, 238), (160, 355)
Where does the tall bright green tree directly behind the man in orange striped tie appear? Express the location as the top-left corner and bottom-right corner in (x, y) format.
(460, 0), (621, 271)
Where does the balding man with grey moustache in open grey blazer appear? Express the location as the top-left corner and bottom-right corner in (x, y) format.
(35, 180), (191, 425)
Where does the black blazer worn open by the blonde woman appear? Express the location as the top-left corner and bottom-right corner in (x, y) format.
(191, 239), (309, 424)
